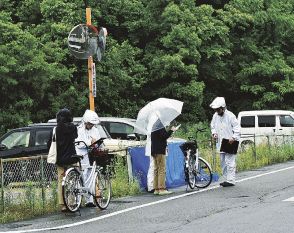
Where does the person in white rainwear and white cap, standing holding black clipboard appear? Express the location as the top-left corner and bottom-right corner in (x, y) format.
(210, 97), (240, 187)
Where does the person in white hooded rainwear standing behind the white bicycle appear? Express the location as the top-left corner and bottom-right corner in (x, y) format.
(76, 109), (101, 207)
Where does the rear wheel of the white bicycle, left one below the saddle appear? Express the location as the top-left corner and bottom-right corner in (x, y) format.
(62, 169), (83, 212)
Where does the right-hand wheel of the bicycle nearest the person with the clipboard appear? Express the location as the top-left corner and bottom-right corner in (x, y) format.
(195, 157), (212, 188)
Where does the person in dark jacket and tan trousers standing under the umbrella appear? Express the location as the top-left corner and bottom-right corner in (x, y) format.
(151, 120), (176, 195)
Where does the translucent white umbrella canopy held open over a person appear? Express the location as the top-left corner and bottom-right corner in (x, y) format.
(136, 98), (183, 134)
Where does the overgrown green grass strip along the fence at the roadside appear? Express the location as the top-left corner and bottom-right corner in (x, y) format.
(0, 135), (294, 223)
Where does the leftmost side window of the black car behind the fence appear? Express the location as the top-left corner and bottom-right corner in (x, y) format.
(1, 131), (30, 149)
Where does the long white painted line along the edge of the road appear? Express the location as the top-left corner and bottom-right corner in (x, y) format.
(0, 166), (294, 233)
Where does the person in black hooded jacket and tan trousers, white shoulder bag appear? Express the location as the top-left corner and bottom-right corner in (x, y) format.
(48, 108), (78, 211)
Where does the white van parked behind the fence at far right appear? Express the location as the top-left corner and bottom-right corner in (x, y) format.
(238, 110), (294, 146)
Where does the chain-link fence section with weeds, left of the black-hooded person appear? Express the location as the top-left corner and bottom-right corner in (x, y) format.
(0, 155), (57, 217)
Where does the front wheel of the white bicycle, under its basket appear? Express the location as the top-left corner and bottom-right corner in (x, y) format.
(94, 173), (111, 210)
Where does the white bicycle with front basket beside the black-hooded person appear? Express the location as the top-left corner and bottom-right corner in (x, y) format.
(62, 139), (112, 212)
